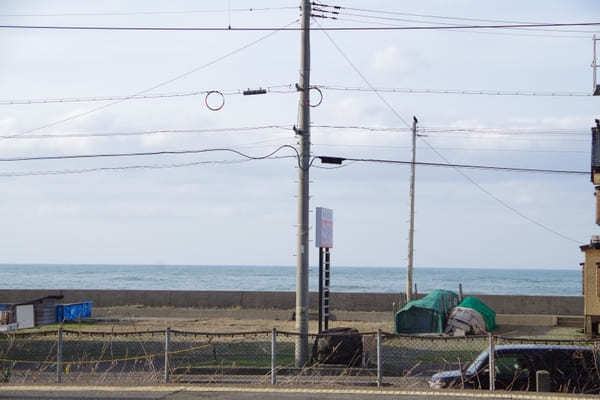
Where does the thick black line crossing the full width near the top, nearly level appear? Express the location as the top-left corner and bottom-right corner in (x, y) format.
(0, 22), (600, 32)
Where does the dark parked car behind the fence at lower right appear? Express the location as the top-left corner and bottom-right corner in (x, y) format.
(429, 344), (600, 394)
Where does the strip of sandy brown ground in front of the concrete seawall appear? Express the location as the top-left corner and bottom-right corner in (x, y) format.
(75, 306), (583, 339)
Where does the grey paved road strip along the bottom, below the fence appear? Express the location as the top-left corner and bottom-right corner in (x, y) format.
(0, 386), (590, 400)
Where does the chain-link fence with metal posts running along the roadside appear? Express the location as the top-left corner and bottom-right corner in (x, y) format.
(0, 328), (600, 393)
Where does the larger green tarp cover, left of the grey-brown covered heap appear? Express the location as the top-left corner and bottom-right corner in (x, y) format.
(395, 289), (458, 333)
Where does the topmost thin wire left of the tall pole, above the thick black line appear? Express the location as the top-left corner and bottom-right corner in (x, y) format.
(0, 6), (298, 18)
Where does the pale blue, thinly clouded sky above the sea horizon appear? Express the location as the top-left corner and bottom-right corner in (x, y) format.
(0, 0), (600, 268)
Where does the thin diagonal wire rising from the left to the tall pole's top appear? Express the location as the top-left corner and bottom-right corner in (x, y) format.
(8, 19), (298, 136)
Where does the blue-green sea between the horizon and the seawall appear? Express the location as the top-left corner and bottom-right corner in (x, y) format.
(0, 264), (581, 296)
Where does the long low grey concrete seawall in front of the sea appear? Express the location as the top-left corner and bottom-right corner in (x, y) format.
(0, 289), (583, 315)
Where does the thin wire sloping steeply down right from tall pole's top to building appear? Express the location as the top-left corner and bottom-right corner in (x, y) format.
(315, 20), (579, 243)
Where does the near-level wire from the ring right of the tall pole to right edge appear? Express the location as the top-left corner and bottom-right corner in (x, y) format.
(317, 85), (592, 97)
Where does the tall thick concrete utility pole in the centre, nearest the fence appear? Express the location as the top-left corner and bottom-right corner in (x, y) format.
(296, 0), (311, 367)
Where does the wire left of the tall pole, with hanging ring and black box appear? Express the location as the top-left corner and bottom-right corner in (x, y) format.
(0, 83), (296, 106)
